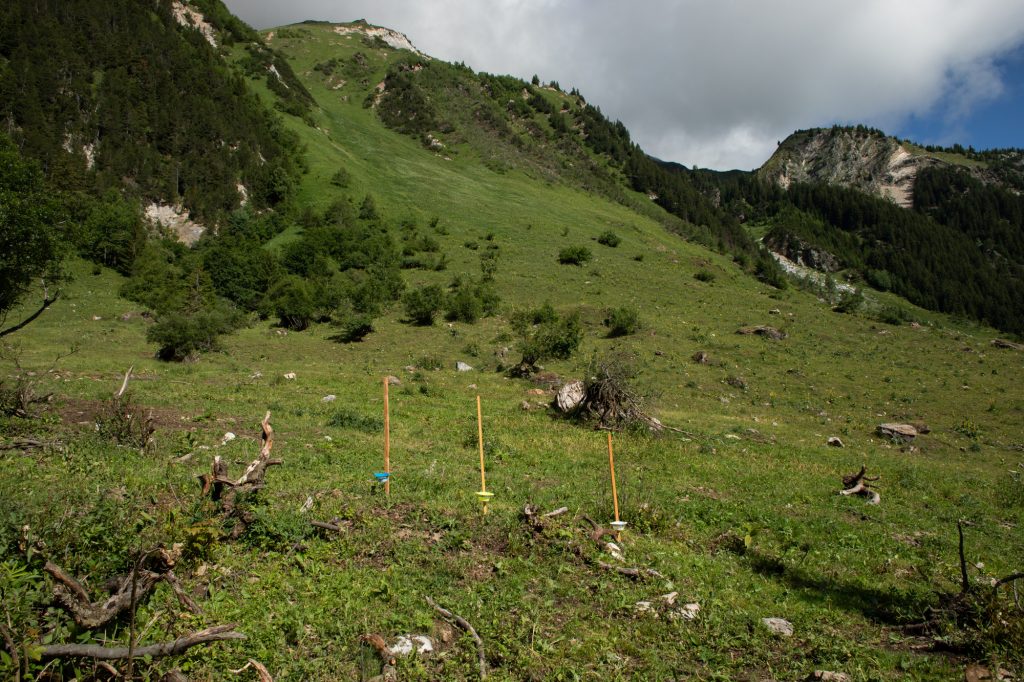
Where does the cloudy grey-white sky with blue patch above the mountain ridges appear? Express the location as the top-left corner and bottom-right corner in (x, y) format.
(225, 0), (1024, 170)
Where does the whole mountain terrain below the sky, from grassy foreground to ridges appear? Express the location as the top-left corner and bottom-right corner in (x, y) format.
(0, 0), (1024, 681)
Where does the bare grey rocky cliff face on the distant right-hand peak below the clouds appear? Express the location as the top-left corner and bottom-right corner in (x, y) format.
(758, 128), (942, 207)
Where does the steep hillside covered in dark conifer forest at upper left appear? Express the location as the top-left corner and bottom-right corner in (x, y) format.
(0, 0), (308, 220)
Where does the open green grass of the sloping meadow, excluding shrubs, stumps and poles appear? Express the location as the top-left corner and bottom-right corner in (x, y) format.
(0, 18), (1024, 680)
